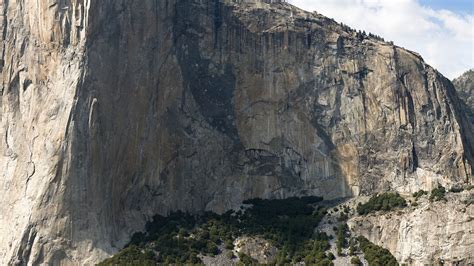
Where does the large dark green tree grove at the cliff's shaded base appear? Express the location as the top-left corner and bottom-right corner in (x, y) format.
(100, 197), (333, 265)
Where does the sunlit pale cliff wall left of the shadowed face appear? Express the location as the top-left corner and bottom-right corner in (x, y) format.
(0, 0), (89, 265)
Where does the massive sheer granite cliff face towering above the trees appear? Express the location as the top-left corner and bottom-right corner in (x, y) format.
(0, 0), (474, 264)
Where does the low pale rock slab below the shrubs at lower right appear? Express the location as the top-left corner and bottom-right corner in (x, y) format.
(348, 192), (474, 265)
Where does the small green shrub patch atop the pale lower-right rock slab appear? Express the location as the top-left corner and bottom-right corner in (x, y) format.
(357, 193), (407, 215)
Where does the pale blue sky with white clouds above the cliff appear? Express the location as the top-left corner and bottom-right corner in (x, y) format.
(289, 0), (474, 79)
